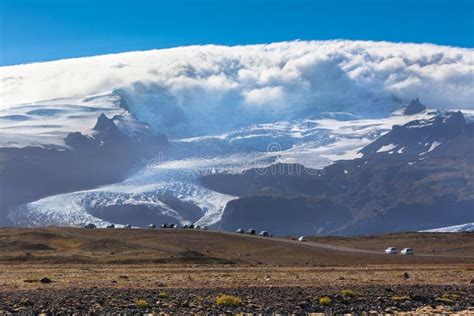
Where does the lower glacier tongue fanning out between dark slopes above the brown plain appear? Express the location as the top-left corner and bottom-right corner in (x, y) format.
(10, 154), (241, 227)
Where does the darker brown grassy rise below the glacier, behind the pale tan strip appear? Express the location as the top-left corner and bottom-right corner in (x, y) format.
(0, 227), (474, 266)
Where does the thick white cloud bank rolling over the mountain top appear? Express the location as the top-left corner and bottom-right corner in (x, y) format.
(0, 40), (474, 135)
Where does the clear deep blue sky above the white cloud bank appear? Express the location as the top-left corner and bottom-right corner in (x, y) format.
(0, 0), (474, 65)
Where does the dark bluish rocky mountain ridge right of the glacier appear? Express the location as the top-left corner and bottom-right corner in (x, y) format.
(201, 108), (474, 235)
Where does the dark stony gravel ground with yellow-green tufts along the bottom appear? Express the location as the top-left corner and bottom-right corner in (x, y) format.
(0, 285), (474, 315)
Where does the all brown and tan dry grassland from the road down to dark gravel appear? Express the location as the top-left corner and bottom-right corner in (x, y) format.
(0, 227), (474, 292)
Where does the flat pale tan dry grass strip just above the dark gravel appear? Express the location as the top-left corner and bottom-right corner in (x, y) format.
(0, 264), (473, 294)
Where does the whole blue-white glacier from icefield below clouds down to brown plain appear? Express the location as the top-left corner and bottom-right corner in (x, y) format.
(10, 112), (438, 226)
